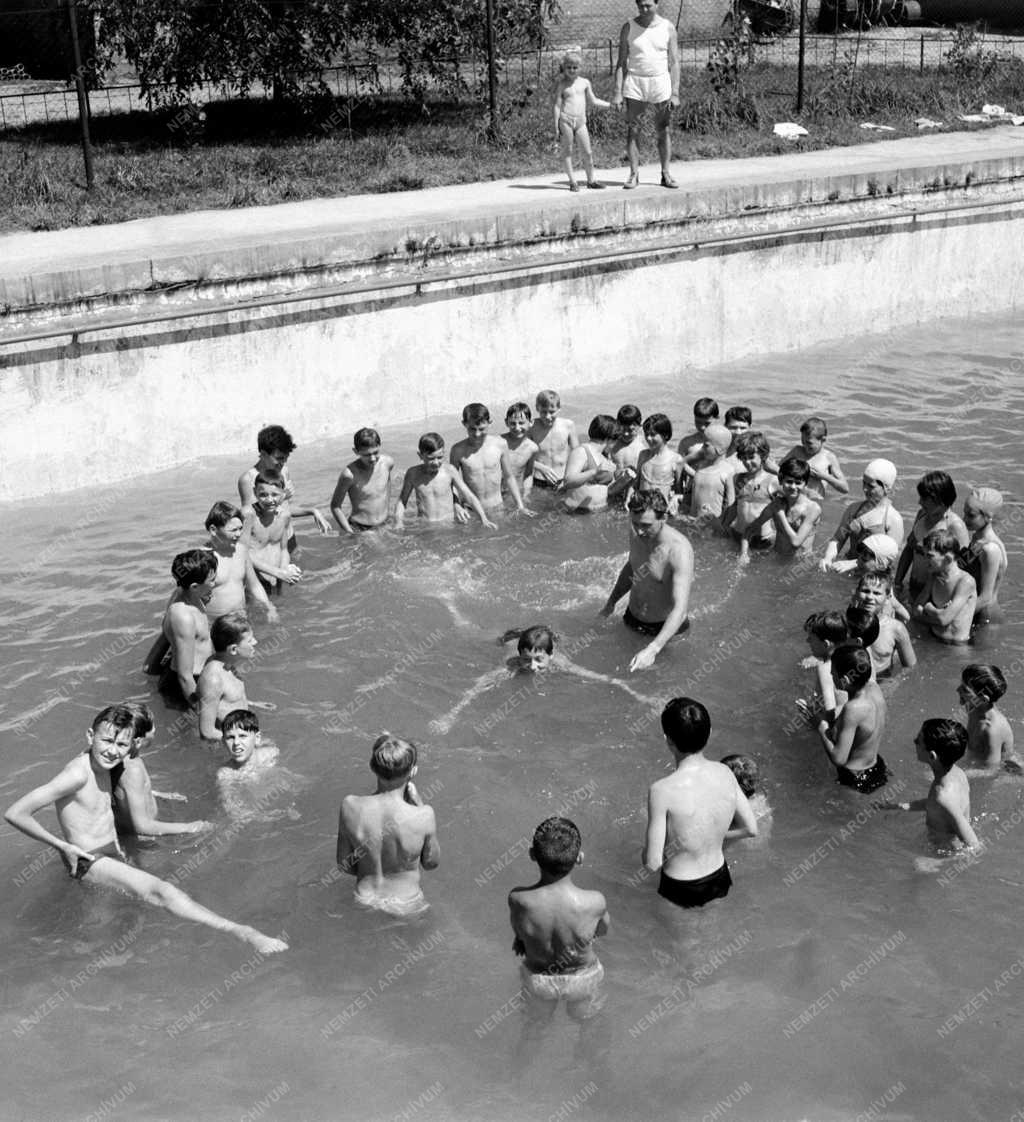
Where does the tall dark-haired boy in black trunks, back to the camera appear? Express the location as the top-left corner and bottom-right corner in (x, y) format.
(643, 698), (757, 908)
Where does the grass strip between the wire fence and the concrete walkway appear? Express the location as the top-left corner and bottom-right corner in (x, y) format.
(0, 61), (1024, 232)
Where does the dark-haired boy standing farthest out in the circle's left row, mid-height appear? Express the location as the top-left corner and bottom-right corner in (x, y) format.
(160, 550), (216, 705)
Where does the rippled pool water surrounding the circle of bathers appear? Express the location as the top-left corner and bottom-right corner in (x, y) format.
(0, 309), (1024, 1122)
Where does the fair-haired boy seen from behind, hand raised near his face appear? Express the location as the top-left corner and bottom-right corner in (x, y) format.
(338, 733), (441, 916)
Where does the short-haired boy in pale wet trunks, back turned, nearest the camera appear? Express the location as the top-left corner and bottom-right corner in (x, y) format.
(508, 818), (610, 1021)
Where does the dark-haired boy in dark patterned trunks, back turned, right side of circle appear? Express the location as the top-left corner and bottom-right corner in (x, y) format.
(818, 645), (889, 794)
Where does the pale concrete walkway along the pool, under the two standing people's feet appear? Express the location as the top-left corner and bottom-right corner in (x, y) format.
(0, 126), (1024, 316)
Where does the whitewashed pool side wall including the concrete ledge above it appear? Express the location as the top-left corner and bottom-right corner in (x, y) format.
(0, 130), (1024, 499)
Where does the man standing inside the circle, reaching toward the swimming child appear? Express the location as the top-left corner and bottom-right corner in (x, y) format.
(601, 490), (693, 670)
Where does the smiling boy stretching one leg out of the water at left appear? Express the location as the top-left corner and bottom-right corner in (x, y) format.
(4, 706), (288, 955)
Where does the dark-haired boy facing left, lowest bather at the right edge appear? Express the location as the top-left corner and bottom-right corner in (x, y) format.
(900, 717), (981, 848)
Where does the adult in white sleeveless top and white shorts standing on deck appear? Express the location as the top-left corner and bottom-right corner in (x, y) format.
(611, 0), (679, 191)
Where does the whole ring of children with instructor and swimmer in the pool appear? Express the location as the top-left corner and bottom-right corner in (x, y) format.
(6, 390), (1020, 1019)
